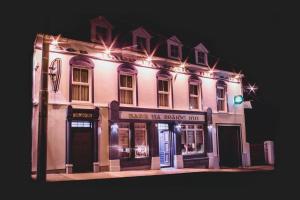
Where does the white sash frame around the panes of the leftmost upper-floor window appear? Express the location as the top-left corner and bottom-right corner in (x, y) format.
(71, 66), (92, 103)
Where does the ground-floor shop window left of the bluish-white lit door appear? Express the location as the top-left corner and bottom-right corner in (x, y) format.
(118, 123), (149, 158)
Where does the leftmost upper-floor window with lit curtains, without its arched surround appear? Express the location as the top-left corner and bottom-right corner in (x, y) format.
(72, 68), (90, 101)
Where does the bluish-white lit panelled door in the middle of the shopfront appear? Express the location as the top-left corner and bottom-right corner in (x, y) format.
(158, 124), (172, 167)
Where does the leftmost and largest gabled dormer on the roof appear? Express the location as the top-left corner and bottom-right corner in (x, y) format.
(90, 16), (113, 44)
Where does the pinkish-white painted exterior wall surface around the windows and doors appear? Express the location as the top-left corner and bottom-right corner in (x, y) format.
(32, 43), (250, 171)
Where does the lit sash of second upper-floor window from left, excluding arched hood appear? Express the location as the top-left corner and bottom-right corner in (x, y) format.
(120, 74), (134, 105)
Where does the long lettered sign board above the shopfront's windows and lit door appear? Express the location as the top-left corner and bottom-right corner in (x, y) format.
(120, 111), (205, 122)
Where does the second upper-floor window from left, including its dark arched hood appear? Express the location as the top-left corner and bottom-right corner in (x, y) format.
(118, 63), (137, 105)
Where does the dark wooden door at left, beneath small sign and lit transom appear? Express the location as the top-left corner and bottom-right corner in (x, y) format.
(72, 128), (93, 172)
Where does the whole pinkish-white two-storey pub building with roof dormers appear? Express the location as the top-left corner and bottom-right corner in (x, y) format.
(32, 17), (250, 173)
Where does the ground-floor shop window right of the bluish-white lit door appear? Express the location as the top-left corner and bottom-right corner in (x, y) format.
(181, 124), (204, 155)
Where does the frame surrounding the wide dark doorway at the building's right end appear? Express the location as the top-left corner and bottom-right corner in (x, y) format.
(216, 123), (243, 167)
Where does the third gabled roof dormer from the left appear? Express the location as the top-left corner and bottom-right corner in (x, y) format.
(167, 35), (183, 60)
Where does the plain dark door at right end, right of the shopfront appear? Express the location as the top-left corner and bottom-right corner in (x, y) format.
(218, 126), (241, 167)
